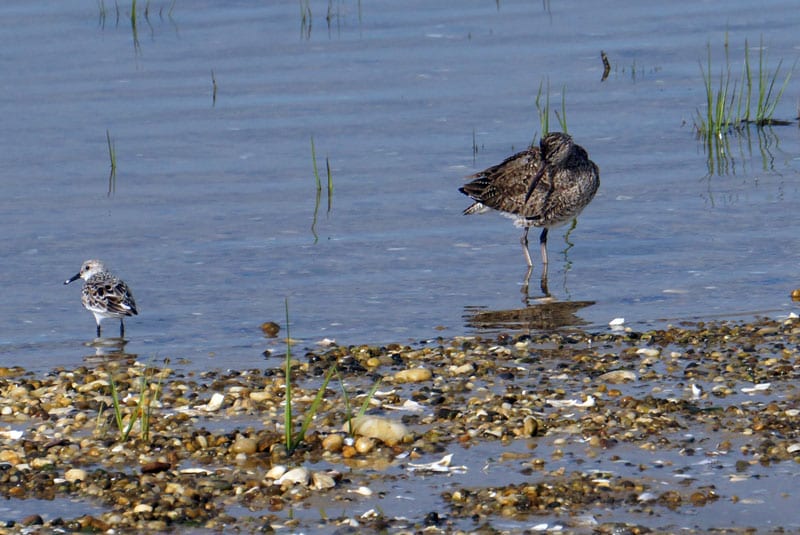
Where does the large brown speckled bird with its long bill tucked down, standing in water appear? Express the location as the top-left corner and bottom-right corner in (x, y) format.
(459, 132), (600, 269)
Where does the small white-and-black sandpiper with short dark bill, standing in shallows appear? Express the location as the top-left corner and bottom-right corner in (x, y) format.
(64, 260), (139, 338)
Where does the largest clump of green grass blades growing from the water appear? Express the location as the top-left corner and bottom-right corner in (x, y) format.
(695, 37), (794, 142)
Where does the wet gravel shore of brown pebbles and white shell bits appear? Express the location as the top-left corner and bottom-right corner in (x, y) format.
(0, 317), (800, 533)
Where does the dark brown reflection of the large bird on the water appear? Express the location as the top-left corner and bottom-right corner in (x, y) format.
(464, 297), (595, 331)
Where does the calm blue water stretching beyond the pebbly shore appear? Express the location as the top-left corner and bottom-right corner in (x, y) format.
(0, 0), (800, 528)
